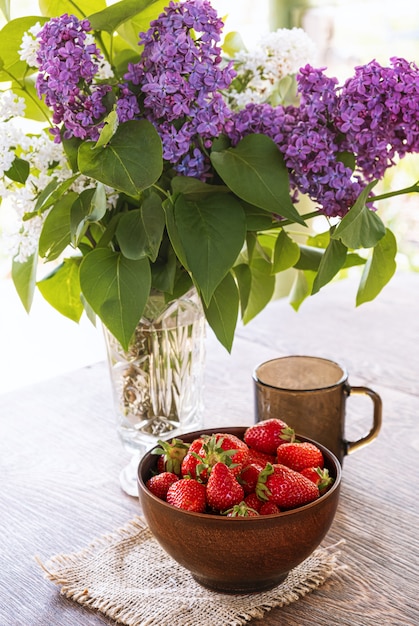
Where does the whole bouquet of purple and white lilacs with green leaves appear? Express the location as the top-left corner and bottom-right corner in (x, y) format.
(0, 0), (419, 349)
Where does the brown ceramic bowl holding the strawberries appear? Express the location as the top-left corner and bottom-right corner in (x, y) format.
(138, 427), (341, 593)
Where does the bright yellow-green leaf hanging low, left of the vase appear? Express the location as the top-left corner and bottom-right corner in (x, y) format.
(37, 257), (83, 322)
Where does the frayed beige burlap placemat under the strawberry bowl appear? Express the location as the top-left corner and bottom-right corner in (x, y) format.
(38, 517), (339, 626)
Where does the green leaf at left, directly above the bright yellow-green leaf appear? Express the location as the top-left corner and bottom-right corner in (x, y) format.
(39, 192), (77, 261)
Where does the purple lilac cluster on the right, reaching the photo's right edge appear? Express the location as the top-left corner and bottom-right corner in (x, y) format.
(228, 59), (419, 216)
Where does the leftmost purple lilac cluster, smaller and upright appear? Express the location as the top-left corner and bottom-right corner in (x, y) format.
(37, 14), (111, 142)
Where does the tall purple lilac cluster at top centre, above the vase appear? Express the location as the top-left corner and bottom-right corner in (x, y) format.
(125, 0), (235, 179)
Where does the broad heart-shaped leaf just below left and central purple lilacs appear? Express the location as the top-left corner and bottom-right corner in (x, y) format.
(79, 120), (163, 197)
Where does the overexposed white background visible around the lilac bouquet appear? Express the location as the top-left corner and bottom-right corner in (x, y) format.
(0, 0), (419, 393)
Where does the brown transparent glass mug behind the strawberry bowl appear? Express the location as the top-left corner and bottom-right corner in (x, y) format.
(253, 356), (382, 463)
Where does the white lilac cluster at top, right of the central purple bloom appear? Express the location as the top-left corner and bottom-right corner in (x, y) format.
(228, 28), (316, 108)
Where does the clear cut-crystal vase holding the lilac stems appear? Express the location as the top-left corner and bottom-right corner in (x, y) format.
(104, 289), (206, 495)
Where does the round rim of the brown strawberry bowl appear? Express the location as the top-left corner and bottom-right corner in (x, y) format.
(137, 426), (342, 523)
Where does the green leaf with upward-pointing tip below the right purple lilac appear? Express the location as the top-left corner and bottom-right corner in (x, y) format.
(332, 181), (386, 250)
